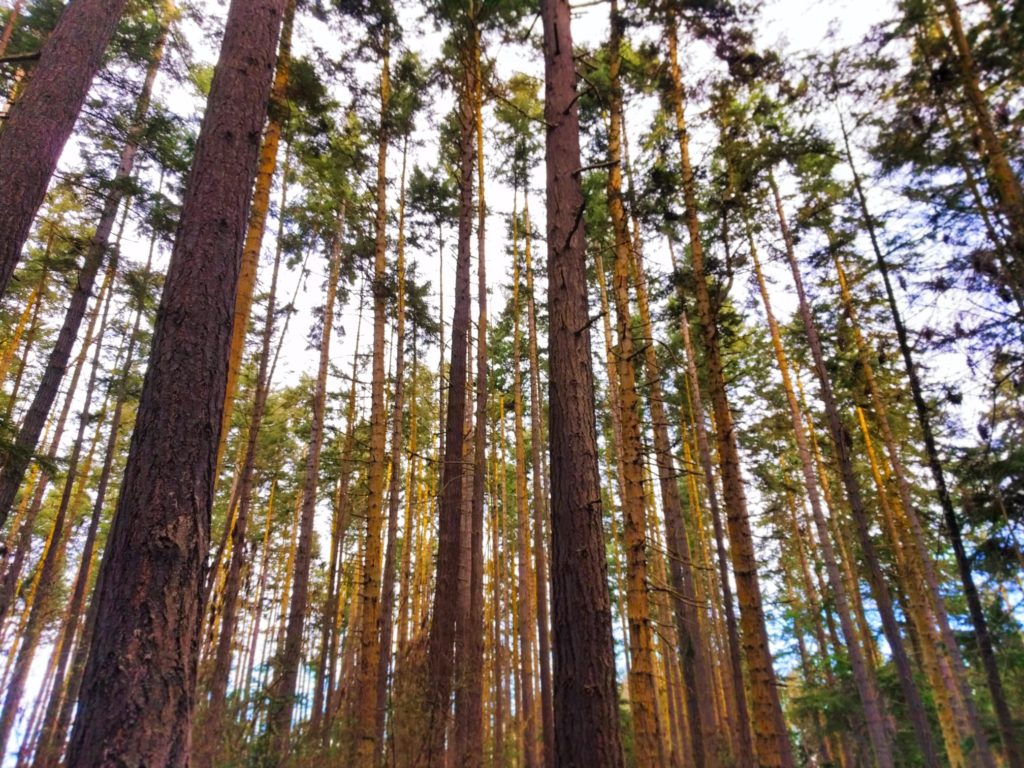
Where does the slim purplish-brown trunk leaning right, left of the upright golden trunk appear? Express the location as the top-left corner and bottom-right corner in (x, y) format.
(267, 200), (345, 764)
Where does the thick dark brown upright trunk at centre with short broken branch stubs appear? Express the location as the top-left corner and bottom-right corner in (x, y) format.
(541, 0), (623, 768)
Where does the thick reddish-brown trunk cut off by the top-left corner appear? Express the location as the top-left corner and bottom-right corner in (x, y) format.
(0, 0), (128, 303)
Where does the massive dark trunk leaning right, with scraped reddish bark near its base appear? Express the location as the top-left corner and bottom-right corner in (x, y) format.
(60, 0), (285, 767)
